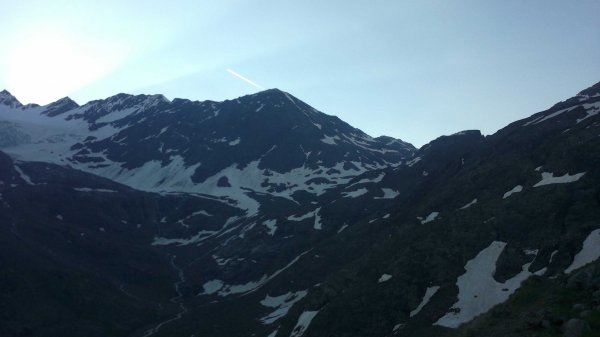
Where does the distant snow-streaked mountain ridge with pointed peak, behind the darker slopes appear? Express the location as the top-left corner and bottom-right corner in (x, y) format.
(0, 89), (415, 211)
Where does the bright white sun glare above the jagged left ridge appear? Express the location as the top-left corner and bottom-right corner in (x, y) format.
(6, 31), (118, 104)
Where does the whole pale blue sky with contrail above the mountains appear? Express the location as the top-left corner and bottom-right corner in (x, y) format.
(0, 0), (600, 146)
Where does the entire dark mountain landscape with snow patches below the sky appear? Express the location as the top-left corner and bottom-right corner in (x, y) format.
(0, 83), (600, 337)
